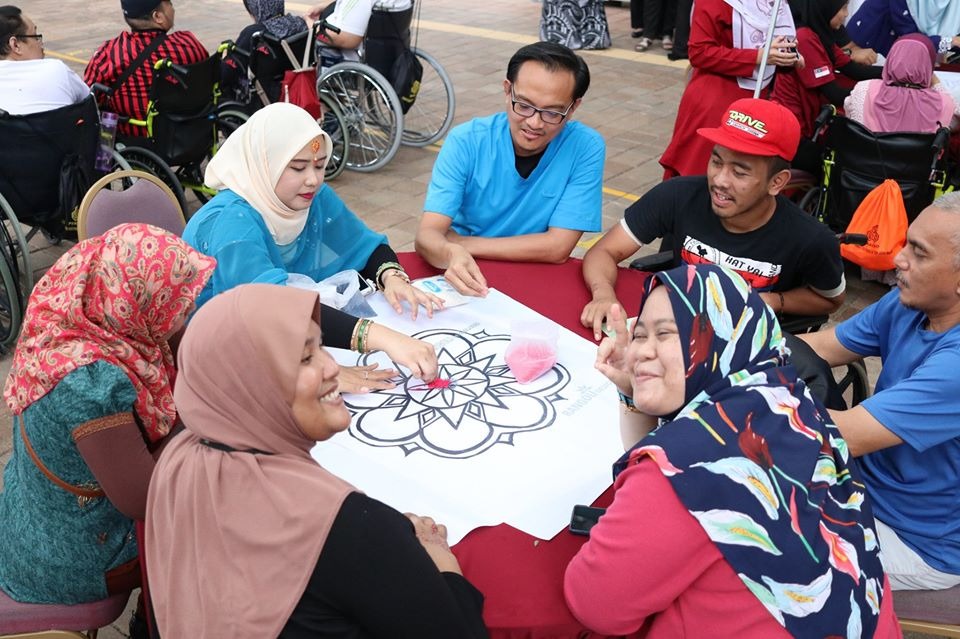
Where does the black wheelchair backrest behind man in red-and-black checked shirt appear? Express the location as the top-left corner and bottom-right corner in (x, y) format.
(139, 53), (221, 166)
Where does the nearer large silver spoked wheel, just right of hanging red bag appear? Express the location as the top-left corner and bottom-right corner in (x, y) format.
(317, 62), (403, 172)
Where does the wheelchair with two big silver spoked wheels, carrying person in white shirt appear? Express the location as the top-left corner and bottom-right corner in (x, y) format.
(317, 2), (456, 172)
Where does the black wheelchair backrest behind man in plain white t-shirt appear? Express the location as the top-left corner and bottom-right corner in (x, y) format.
(0, 95), (100, 237)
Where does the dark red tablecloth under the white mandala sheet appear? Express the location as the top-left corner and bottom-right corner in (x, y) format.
(400, 253), (646, 639)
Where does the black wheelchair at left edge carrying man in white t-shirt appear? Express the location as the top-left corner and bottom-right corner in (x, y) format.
(0, 95), (130, 348)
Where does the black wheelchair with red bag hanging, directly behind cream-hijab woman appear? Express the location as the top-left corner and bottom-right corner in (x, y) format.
(230, 31), (350, 180)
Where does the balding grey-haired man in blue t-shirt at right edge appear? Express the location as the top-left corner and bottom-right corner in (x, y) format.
(802, 193), (960, 590)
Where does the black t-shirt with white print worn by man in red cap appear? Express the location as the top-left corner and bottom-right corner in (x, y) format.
(623, 176), (845, 297)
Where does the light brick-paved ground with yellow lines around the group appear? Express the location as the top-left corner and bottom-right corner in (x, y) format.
(0, 0), (900, 639)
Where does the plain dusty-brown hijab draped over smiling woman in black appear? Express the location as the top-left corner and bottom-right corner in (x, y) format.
(146, 284), (354, 639)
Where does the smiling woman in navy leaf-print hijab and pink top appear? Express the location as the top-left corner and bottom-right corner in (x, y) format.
(568, 265), (901, 639)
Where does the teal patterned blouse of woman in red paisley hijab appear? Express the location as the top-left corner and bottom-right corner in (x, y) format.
(0, 361), (137, 604)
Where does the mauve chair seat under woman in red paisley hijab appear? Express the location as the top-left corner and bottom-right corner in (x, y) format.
(0, 590), (130, 639)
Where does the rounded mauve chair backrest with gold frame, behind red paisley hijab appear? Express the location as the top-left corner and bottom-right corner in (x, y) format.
(77, 170), (186, 240)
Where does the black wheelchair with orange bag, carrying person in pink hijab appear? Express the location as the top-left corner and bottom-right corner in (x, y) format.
(800, 105), (950, 232)
